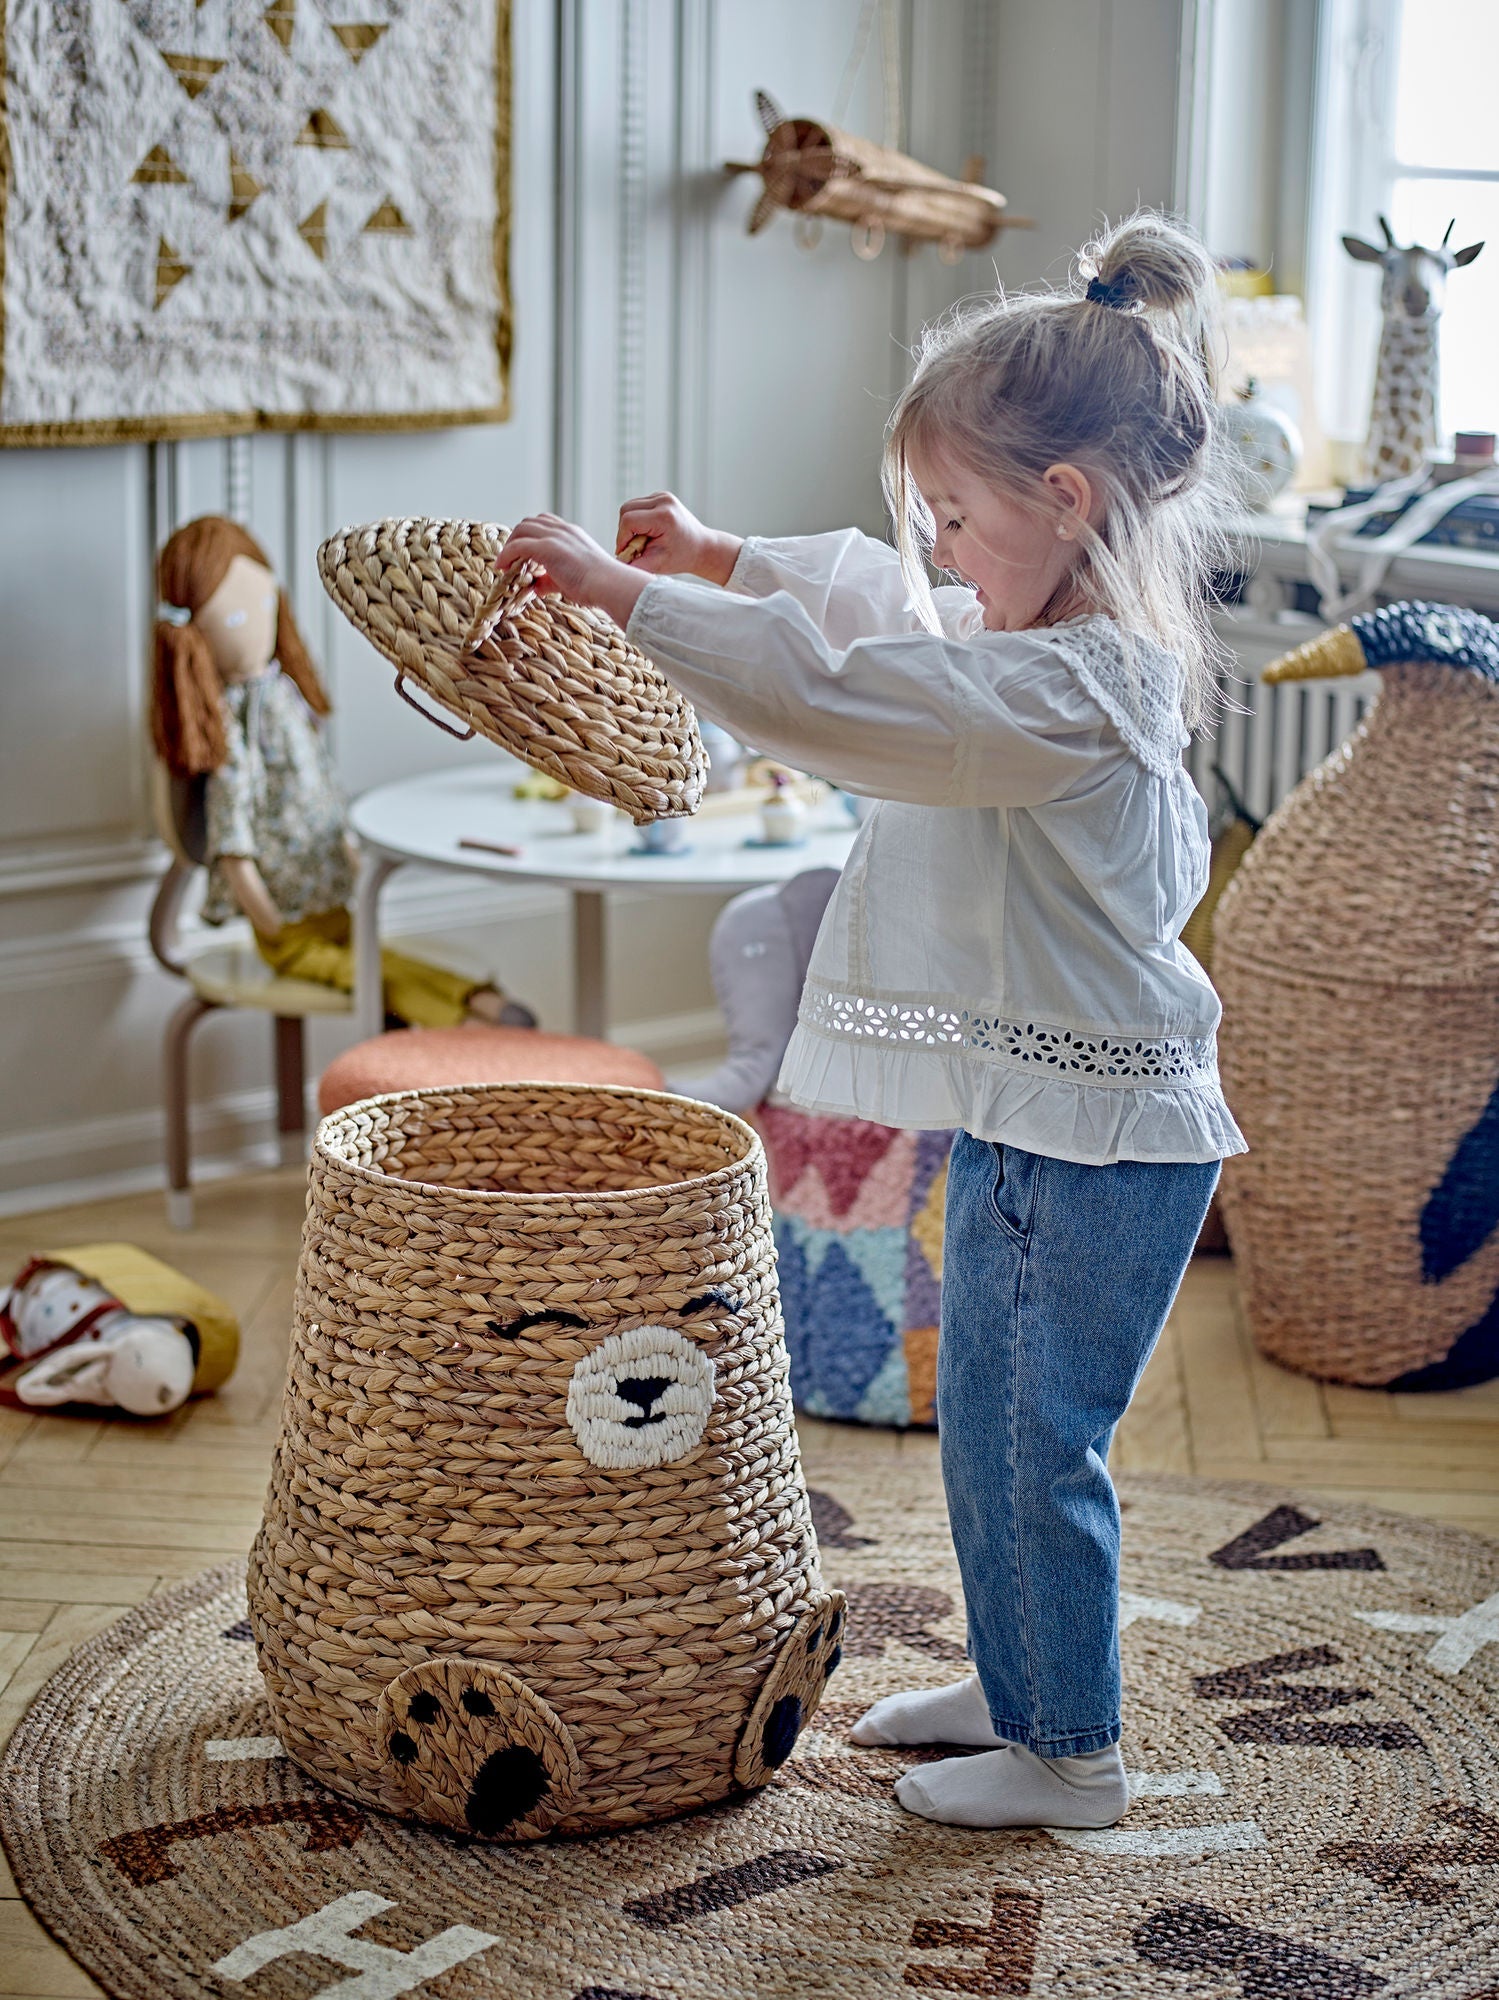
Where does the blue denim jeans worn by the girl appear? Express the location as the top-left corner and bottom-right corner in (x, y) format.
(937, 1132), (1219, 1756)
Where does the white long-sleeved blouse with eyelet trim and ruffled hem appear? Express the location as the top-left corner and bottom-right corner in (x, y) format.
(628, 528), (1247, 1166)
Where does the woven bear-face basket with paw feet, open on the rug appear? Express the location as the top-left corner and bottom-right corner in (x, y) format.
(240, 1084), (843, 1840)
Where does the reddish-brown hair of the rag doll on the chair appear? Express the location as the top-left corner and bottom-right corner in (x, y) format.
(152, 514), (328, 778)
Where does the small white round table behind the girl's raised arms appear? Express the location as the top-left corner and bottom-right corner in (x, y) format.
(350, 758), (855, 1036)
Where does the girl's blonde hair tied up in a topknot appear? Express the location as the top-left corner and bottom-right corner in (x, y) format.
(883, 210), (1233, 728)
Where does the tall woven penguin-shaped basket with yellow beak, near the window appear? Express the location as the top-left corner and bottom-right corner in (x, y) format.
(1213, 606), (1499, 1388)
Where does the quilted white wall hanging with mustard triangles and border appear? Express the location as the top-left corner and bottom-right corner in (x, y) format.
(0, 0), (512, 444)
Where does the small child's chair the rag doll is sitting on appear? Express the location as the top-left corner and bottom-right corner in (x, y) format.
(150, 764), (354, 1230)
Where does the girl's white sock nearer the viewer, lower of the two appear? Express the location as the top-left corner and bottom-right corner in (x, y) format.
(895, 1744), (1129, 1826)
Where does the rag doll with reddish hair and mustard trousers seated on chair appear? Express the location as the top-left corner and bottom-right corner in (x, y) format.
(152, 514), (536, 1028)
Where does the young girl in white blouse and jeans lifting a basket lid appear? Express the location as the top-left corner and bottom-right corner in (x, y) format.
(504, 216), (1245, 1826)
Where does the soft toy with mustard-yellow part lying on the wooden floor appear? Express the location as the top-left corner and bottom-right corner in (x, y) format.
(0, 1244), (240, 1416)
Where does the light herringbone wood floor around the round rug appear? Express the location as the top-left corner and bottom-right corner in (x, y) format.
(0, 1170), (1499, 2000)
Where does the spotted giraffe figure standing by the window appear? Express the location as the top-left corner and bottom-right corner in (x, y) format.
(1343, 216), (1483, 482)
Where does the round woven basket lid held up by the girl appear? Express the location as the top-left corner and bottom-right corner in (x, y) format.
(318, 520), (708, 826)
